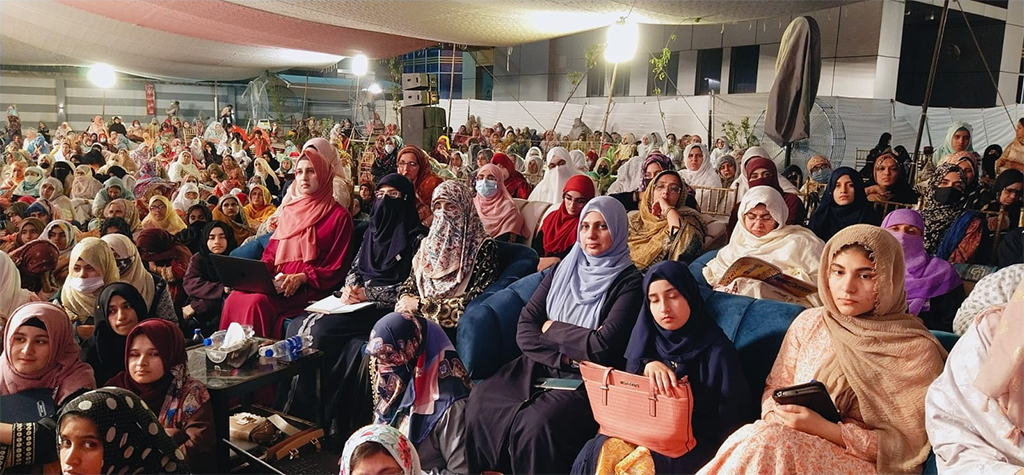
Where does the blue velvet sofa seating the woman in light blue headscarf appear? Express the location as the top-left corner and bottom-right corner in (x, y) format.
(458, 266), (958, 474)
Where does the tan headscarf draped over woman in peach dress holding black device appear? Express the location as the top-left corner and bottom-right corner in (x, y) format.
(815, 224), (946, 473)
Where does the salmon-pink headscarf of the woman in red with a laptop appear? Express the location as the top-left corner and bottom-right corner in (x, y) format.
(272, 137), (339, 265)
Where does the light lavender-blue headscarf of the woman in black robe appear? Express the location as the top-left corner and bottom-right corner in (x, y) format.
(546, 197), (633, 330)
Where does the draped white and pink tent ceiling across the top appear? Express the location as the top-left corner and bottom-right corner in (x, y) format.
(0, 0), (859, 80)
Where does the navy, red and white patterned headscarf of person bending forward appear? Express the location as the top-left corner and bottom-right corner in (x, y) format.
(366, 312), (472, 444)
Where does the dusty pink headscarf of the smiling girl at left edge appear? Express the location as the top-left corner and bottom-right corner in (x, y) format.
(0, 302), (96, 404)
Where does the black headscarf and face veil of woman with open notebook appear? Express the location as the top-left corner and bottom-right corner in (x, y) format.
(358, 173), (427, 286)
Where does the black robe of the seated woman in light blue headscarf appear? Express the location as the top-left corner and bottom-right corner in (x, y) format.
(466, 266), (643, 474)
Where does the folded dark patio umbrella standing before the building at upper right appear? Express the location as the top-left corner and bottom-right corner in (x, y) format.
(765, 16), (821, 146)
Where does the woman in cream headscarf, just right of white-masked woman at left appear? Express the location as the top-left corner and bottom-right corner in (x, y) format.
(101, 233), (178, 322)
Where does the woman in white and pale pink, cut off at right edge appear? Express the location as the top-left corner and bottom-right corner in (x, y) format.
(925, 283), (1024, 474)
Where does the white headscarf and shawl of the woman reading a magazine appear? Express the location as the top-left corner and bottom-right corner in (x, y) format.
(702, 186), (825, 287)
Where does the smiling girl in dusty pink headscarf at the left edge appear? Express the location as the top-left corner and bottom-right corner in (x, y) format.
(0, 302), (96, 473)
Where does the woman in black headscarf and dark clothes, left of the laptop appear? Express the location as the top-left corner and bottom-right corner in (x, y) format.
(181, 221), (236, 335)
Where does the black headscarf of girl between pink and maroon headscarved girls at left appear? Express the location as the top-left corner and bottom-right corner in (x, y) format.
(82, 283), (150, 386)
